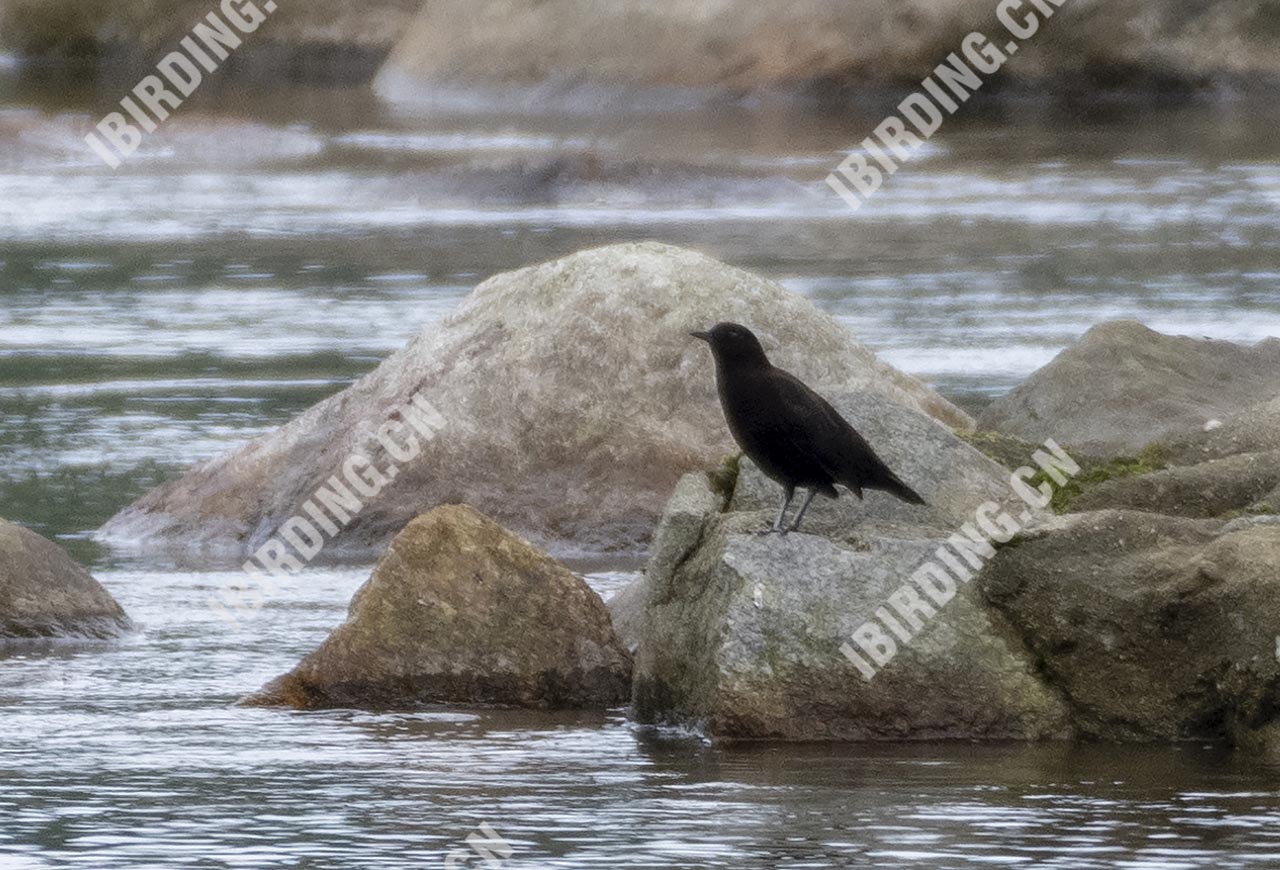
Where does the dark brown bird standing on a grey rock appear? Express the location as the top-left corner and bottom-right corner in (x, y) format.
(690, 324), (924, 535)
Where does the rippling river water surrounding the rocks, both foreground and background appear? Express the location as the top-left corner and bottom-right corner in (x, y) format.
(0, 64), (1280, 869)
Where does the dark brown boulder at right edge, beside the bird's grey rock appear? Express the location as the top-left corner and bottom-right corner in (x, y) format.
(978, 510), (1280, 746)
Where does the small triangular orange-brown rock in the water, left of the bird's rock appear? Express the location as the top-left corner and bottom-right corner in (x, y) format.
(244, 505), (631, 709)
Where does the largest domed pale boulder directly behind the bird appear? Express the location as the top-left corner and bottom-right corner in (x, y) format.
(101, 243), (972, 553)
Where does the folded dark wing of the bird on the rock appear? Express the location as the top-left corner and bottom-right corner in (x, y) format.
(774, 368), (892, 495)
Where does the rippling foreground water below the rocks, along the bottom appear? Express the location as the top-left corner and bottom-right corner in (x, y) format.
(0, 566), (1280, 870)
